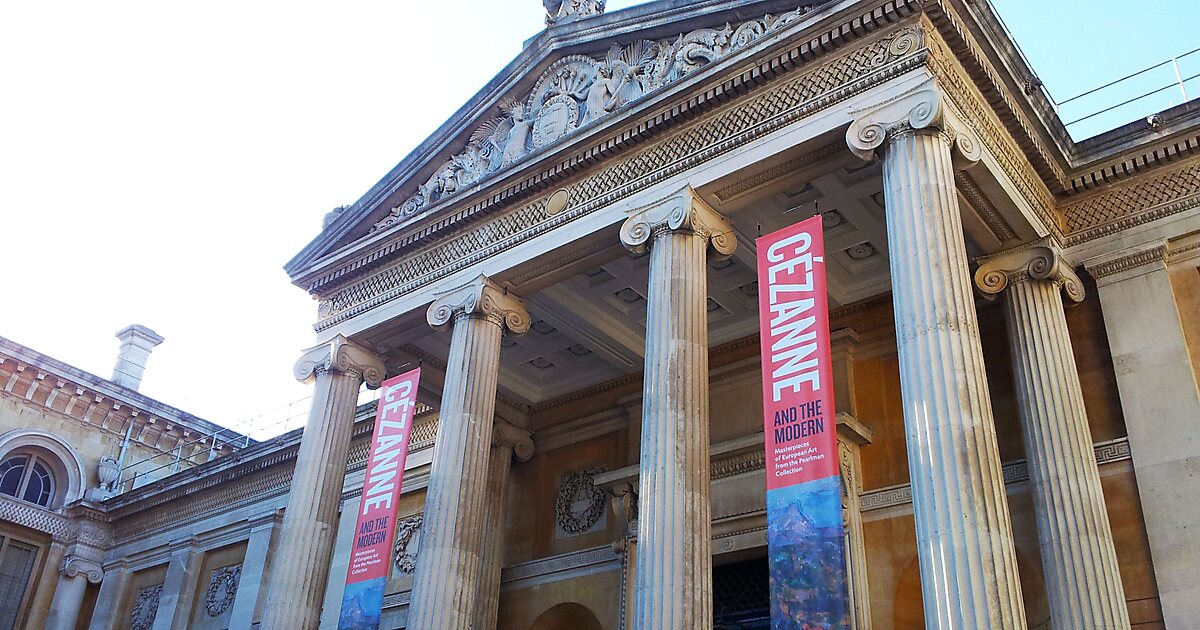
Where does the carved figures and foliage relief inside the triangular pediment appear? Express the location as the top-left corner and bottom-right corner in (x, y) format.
(372, 6), (812, 232)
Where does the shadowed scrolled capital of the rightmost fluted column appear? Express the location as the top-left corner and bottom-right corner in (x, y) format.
(974, 239), (1084, 302)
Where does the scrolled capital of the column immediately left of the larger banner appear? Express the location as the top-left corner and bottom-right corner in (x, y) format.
(620, 186), (738, 259)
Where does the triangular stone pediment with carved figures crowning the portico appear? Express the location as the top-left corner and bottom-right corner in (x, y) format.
(286, 0), (822, 278)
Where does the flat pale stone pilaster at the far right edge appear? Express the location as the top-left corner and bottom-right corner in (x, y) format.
(1085, 240), (1200, 630)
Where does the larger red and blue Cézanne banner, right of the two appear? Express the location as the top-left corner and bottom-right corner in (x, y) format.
(757, 215), (850, 630)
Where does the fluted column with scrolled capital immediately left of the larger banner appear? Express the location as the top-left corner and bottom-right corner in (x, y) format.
(620, 187), (737, 630)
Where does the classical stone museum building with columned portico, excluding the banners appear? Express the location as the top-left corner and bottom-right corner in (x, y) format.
(0, 0), (1200, 630)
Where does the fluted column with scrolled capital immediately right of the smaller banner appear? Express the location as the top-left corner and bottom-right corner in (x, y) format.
(408, 276), (529, 630)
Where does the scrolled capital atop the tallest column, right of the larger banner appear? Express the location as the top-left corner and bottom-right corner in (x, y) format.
(846, 86), (983, 168)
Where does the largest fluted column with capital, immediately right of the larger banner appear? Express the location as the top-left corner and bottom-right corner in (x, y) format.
(846, 89), (1026, 630)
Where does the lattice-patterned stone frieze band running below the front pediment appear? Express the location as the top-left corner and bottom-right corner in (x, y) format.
(314, 25), (928, 330)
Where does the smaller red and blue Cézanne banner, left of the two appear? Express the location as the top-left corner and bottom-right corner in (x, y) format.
(337, 368), (421, 630)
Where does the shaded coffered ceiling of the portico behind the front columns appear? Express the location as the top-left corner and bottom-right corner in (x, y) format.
(384, 137), (907, 404)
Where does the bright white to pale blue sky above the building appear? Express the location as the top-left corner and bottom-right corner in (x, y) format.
(0, 0), (1200, 428)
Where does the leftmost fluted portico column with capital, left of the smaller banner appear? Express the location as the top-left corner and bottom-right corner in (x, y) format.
(262, 335), (384, 630)
